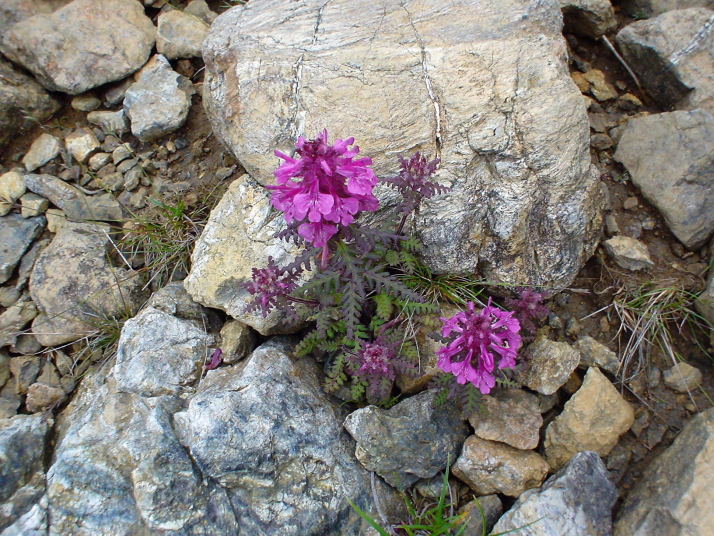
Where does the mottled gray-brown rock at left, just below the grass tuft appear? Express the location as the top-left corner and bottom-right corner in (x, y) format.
(30, 222), (144, 346)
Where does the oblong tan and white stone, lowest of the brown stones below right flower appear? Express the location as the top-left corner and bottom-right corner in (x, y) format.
(453, 436), (550, 497)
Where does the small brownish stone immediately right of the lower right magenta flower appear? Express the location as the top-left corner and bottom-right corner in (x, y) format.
(516, 336), (580, 395)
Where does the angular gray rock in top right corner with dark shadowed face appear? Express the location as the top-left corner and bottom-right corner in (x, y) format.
(617, 7), (714, 113)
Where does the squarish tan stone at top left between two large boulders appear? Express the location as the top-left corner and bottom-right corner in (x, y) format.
(156, 10), (209, 60)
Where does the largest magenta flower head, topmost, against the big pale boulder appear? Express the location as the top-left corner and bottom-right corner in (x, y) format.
(268, 130), (379, 248)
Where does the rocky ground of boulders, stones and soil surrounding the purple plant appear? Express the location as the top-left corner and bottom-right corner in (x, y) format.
(0, 0), (714, 536)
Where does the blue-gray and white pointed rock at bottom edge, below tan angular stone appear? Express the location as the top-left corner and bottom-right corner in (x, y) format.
(493, 451), (617, 536)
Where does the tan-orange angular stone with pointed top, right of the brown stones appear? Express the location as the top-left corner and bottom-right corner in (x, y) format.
(544, 367), (635, 469)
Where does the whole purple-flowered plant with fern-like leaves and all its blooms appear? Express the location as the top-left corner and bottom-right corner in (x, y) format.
(244, 130), (521, 404)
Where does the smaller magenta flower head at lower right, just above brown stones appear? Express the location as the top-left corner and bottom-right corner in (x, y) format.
(437, 298), (521, 394)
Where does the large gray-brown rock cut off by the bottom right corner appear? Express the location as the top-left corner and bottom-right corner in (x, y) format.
(615, 408), (714, 536)
